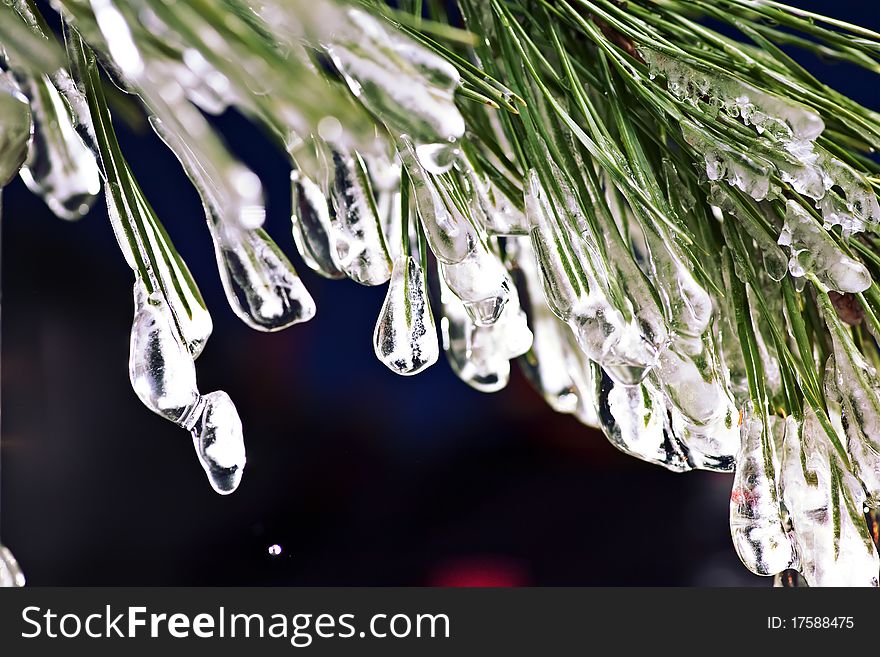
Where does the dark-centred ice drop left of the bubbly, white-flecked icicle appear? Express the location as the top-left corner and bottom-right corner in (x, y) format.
(290, 169), (345, 278)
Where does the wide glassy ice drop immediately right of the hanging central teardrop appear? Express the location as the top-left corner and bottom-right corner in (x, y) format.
(440, 270), (532, 392)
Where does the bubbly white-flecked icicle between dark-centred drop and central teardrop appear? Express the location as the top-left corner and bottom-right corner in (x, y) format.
(330, 150), (392, 285)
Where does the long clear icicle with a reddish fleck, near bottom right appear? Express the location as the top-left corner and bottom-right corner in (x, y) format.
(730, 404), (795, 575)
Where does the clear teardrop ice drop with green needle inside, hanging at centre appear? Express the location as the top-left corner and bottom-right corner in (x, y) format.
(373, 255), (440, 376)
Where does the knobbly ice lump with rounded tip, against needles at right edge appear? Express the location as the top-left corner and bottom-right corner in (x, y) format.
(779, 200), (871, 292)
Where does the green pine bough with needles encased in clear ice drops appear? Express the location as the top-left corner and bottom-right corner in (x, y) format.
(0, 0), (880, 586)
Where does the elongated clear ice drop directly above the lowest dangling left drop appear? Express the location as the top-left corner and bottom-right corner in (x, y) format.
(128, 277), (199, 424)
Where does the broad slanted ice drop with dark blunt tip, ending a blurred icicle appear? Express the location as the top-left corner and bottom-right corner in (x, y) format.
(212, 224), (315, 331)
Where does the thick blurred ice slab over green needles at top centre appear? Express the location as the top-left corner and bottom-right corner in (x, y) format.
(325, 8), (465, 172)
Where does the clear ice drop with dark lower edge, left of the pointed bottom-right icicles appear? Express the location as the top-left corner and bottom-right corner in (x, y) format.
(597, 372), (692, 472)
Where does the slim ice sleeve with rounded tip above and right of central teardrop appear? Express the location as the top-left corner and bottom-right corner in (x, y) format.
(399, 137), (479, 264)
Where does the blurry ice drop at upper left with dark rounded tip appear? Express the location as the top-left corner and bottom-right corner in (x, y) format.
(21, 77), (101, 219)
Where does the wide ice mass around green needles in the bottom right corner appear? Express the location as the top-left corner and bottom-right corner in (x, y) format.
(779, 408), (880, 587)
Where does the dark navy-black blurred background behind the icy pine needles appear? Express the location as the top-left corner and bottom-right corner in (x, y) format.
(0, 0), (880, 586)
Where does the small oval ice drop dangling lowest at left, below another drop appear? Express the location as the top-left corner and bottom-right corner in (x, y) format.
(192, 390), (247, 495)
